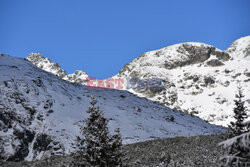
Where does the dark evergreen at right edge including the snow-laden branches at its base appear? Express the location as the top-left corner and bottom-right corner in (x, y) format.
(220, 87), (250, 167)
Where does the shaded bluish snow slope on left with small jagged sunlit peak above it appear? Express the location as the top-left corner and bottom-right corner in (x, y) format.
(0, 54), (225, 161)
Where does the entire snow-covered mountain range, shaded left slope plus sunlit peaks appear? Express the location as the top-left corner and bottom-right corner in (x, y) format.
(0, 36), (250, 161)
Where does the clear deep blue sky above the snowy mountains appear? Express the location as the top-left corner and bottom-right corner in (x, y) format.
(0, 0), (250, 78)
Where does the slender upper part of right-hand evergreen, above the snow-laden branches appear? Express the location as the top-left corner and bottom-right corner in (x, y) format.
(229, 86), (247, 135)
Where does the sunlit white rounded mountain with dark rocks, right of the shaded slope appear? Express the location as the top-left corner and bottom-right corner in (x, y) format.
(113, 36), (250, 126)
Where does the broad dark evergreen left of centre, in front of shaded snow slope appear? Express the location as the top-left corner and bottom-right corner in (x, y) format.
(72, 97), (122, 167)
